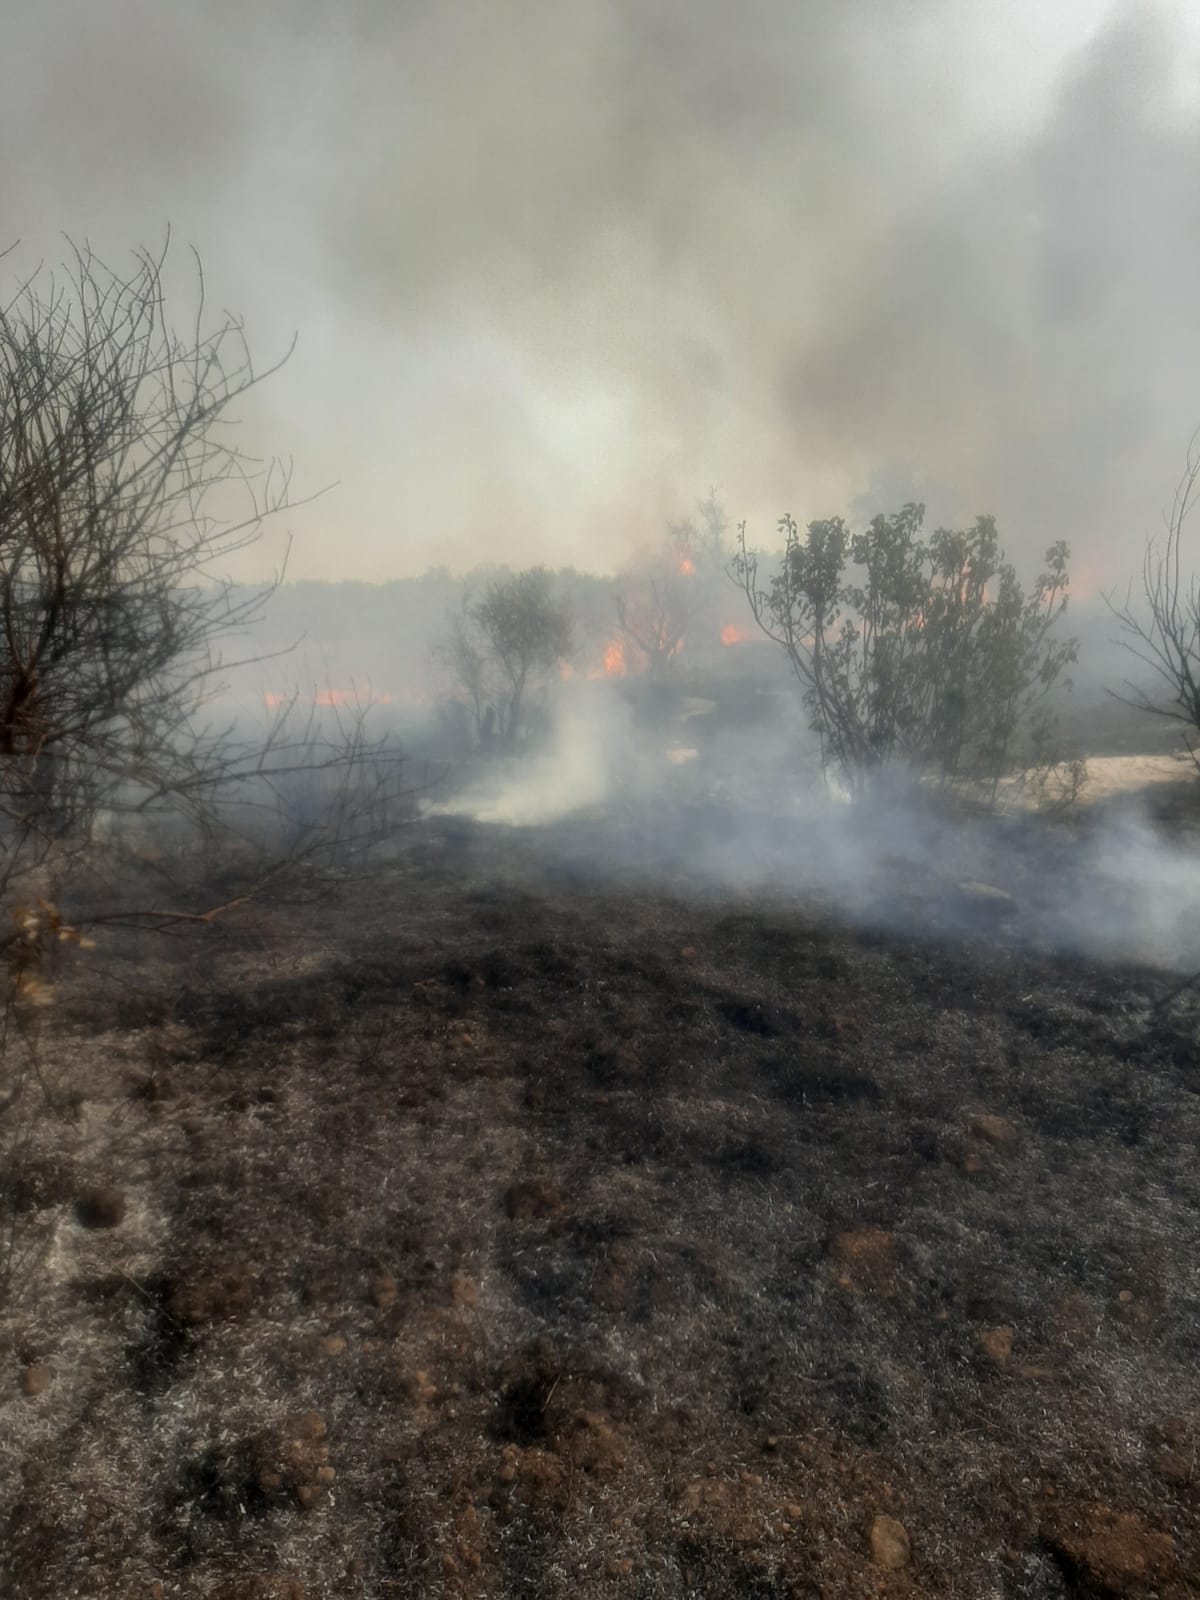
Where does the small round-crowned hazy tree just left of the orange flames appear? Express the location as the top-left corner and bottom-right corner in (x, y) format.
(440, 566), (573, 749)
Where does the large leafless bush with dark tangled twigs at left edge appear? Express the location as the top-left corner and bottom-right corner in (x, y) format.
(0, 236), (406, 1305)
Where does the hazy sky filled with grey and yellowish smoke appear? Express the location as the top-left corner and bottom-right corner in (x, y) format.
(0, 0), (1200, 586)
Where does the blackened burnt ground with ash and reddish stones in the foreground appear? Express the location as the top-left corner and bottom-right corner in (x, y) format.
(0, 793), (1200, 1600)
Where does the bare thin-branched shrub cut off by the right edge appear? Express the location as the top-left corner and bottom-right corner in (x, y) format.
(1104, 430), (1200, 758)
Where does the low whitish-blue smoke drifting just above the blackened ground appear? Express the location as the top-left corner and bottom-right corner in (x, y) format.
(424, 685), (1200, 971)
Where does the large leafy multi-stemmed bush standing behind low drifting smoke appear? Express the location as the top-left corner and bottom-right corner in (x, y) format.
(731, 504), (1077, 794)
